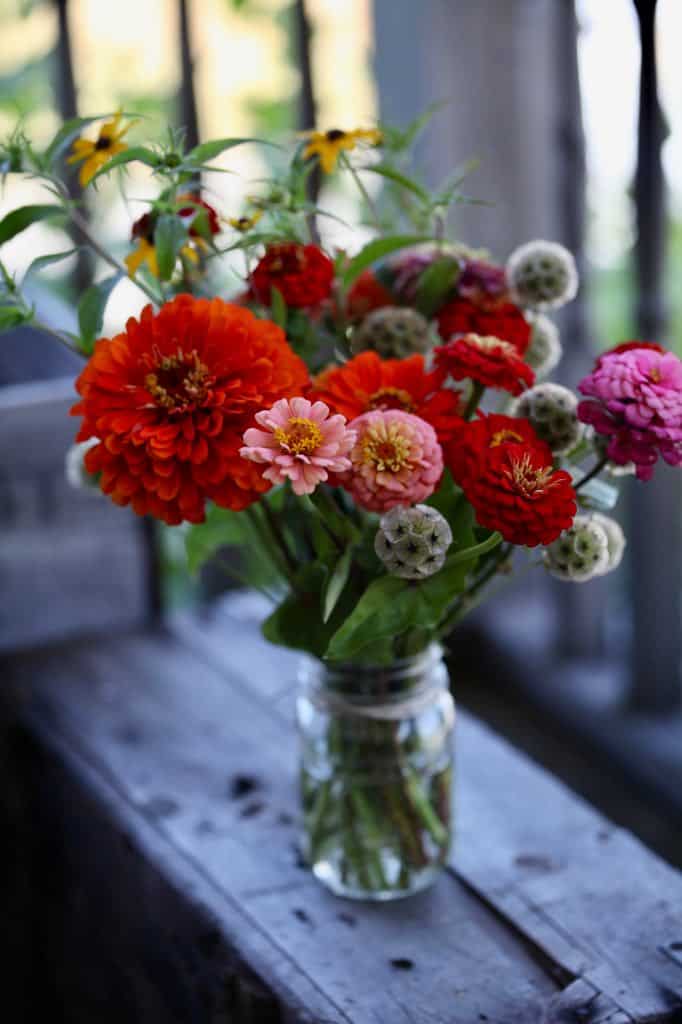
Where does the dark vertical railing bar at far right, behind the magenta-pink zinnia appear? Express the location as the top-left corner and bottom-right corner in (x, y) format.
(629, 0), (682, 712)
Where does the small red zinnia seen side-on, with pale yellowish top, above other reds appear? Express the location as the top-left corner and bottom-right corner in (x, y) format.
(434, 334), (536, 394)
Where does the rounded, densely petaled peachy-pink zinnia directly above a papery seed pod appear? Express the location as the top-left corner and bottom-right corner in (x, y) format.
(339, 409), (442, 512)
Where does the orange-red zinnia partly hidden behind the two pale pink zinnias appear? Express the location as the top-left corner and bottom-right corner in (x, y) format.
(310, 352), (462, 441)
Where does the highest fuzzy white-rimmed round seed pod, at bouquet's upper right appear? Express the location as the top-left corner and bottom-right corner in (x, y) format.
(507, 240), (578, 310)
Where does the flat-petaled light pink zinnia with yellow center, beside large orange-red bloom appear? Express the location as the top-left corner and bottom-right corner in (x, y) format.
(240, 398), (355, 495)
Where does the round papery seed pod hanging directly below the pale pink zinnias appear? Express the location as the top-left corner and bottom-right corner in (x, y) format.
(374, 505), (453, 580)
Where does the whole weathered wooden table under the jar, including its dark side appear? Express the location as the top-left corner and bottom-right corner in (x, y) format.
(3, 596), (682, 1024)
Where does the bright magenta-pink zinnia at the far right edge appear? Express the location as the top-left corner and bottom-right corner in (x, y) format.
(578, 347), (682, 480)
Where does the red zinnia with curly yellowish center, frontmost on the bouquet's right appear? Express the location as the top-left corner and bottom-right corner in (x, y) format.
(463, 444), (578, 548)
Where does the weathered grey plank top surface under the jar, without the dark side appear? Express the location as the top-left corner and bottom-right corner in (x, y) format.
(5, 606), (682, 1024)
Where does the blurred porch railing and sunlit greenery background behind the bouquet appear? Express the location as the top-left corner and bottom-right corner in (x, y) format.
(0, 0), (682, 863)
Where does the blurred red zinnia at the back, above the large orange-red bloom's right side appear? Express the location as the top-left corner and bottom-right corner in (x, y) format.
(251, 242), (334, 308)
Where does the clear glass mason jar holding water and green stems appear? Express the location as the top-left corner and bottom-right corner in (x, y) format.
(297, 644), (455, 900)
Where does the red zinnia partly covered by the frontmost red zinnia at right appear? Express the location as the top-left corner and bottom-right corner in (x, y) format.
(443, 411), (552, 486)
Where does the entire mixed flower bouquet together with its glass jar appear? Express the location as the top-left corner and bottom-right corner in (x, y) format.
(0, 114), (682, 898)
